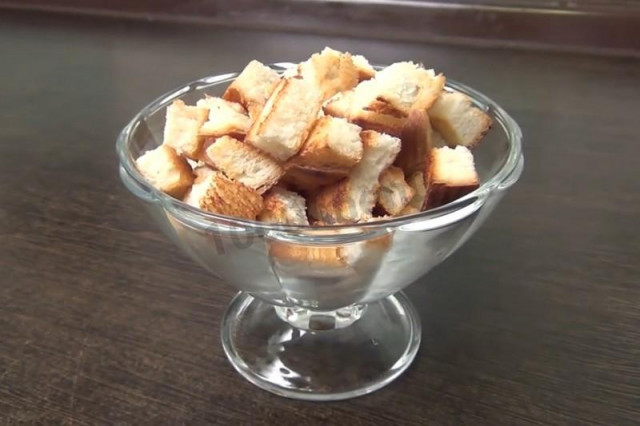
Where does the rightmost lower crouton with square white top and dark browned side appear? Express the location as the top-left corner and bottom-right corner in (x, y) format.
(426, 146), (480, 209)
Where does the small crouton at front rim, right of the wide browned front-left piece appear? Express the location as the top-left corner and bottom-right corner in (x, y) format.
(258, 187), (309, 225)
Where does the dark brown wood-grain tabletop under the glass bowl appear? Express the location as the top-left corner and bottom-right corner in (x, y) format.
(0, 12), (640, 426)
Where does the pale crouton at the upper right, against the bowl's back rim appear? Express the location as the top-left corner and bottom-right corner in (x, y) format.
(429, 92), (491, 147)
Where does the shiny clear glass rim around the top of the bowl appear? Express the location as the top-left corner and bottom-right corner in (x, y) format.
(116, 62), (524, 232)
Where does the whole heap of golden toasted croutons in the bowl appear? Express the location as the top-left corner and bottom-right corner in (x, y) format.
(136, 48), (491, 226)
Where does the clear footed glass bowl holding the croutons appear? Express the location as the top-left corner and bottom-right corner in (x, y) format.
(117, 63), (524, 401)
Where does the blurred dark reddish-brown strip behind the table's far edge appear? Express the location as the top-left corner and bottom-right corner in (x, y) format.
(0, 0), (640, 56)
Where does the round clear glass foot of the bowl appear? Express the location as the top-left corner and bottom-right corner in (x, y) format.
(222, 293), (421, 401)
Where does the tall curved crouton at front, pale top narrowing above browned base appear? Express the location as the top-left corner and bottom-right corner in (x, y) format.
(308, 130), (400, 225)
